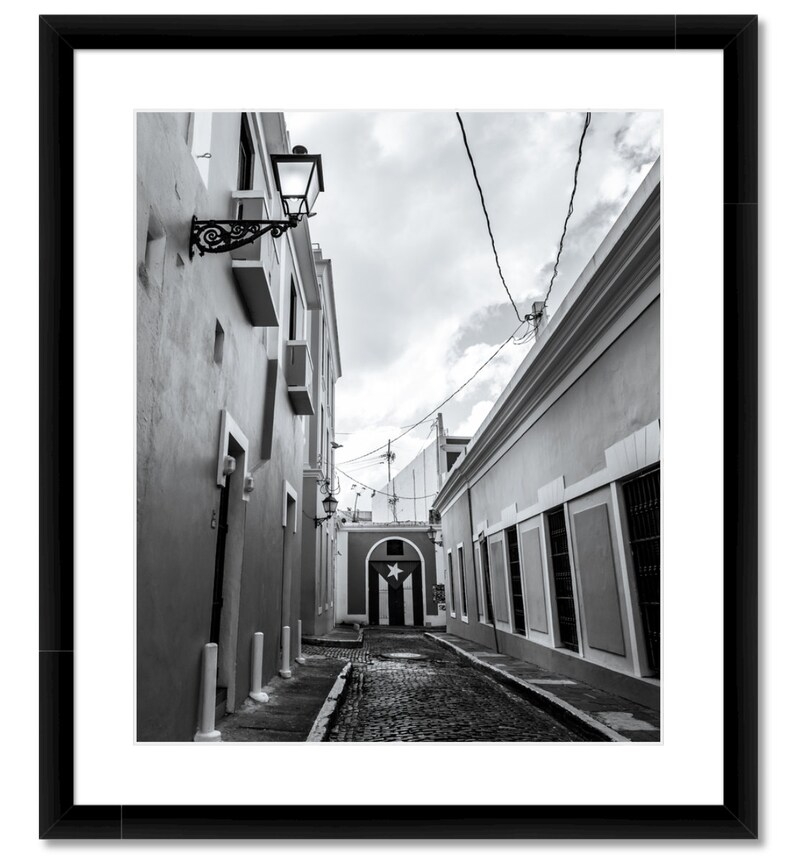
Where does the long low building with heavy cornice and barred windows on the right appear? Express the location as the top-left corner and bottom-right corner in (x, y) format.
(435, 162), (661, 708)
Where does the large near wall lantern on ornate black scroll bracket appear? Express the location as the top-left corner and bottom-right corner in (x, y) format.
(188, 146), (325, 259)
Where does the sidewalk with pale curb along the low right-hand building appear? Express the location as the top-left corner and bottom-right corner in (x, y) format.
(425, 631), (661, 741)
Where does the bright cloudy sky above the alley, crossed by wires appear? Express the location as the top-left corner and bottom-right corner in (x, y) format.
(286, 111), (661, 509)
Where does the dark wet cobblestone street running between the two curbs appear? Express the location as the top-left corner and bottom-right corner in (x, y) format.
(305, 629), (588, 741)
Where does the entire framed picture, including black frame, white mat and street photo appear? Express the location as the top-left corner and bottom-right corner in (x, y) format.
(39, 15), (758, 839)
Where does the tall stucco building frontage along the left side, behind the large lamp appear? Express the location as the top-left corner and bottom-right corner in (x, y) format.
(136, 113), (339, 741)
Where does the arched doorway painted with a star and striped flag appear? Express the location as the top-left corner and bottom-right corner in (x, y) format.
(365, 536), (425, 627)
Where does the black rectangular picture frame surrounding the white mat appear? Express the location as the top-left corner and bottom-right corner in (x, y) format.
(39, 15), (758, 839)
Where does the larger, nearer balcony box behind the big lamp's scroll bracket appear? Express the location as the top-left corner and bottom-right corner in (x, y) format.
(230, 190), (278, 327)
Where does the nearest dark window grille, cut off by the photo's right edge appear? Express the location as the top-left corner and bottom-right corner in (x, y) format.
(623, 468), (661, 673)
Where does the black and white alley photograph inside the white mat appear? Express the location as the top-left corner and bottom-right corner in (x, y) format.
(135, 109), (664, 742)
